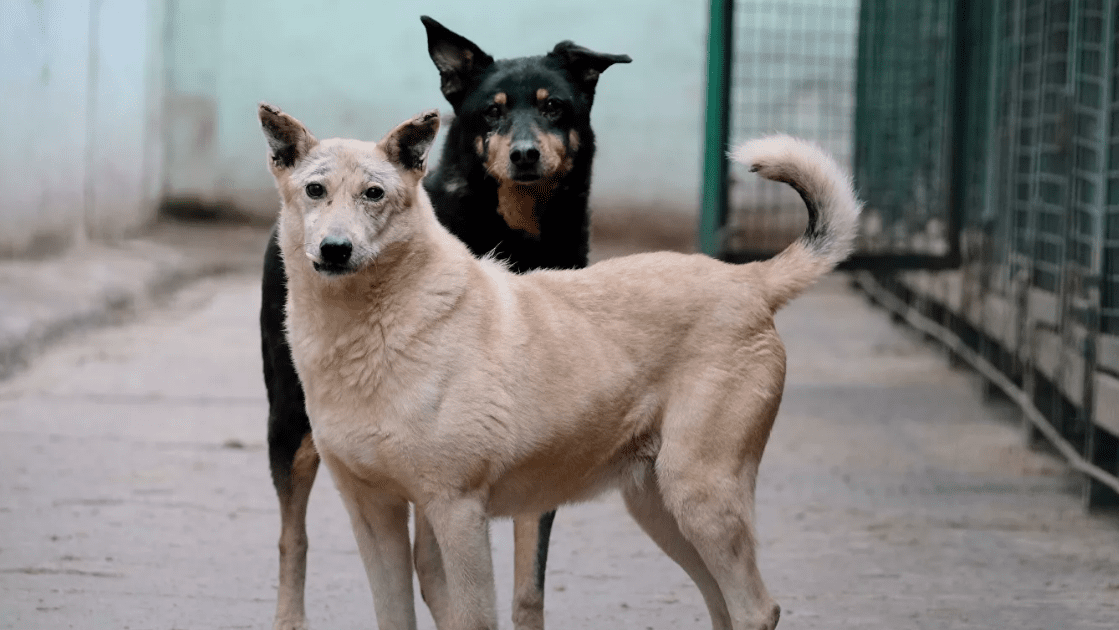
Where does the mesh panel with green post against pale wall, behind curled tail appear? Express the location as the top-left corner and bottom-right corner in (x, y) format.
(699, 0), (858, 257)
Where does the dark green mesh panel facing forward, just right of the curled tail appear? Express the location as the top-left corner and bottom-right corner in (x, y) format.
(855, 0), (962, 261)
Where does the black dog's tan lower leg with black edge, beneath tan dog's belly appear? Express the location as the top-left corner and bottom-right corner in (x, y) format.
(513, 510), (556, 630)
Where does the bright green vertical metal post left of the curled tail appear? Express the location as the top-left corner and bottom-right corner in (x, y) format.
(696, 0), (734, 256)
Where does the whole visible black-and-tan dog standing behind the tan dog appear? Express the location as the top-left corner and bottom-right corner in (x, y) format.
(261, 16), (630, 630)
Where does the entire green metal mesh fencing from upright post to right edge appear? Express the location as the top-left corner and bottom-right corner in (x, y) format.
(700, 0), (1119, 506)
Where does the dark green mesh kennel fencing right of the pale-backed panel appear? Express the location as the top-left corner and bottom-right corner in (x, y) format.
(855, 0), (1119, 506)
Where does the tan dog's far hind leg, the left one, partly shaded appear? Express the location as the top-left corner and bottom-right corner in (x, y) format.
(622, 470), (732, 630)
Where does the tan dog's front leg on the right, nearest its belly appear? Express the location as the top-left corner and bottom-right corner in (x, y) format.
(423, 496), (497, 630)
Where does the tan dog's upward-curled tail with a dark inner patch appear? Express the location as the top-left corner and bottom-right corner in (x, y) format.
(733, 135), (862, 311)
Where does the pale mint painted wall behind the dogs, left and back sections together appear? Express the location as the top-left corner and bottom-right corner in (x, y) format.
(0, 0), (707, 256)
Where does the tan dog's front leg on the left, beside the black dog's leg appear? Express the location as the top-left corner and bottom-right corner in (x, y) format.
(333, 457), (416, 630)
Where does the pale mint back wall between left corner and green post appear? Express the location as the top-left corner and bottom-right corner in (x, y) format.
(163, 0), (707, 221)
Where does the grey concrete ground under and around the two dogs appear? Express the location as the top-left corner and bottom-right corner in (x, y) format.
(0, 229), (1119, 630)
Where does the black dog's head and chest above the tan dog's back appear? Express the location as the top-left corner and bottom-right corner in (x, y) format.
(421, 18), (630, 271)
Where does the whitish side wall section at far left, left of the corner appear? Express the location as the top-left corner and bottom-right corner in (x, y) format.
(0, 0), (163, 255)
